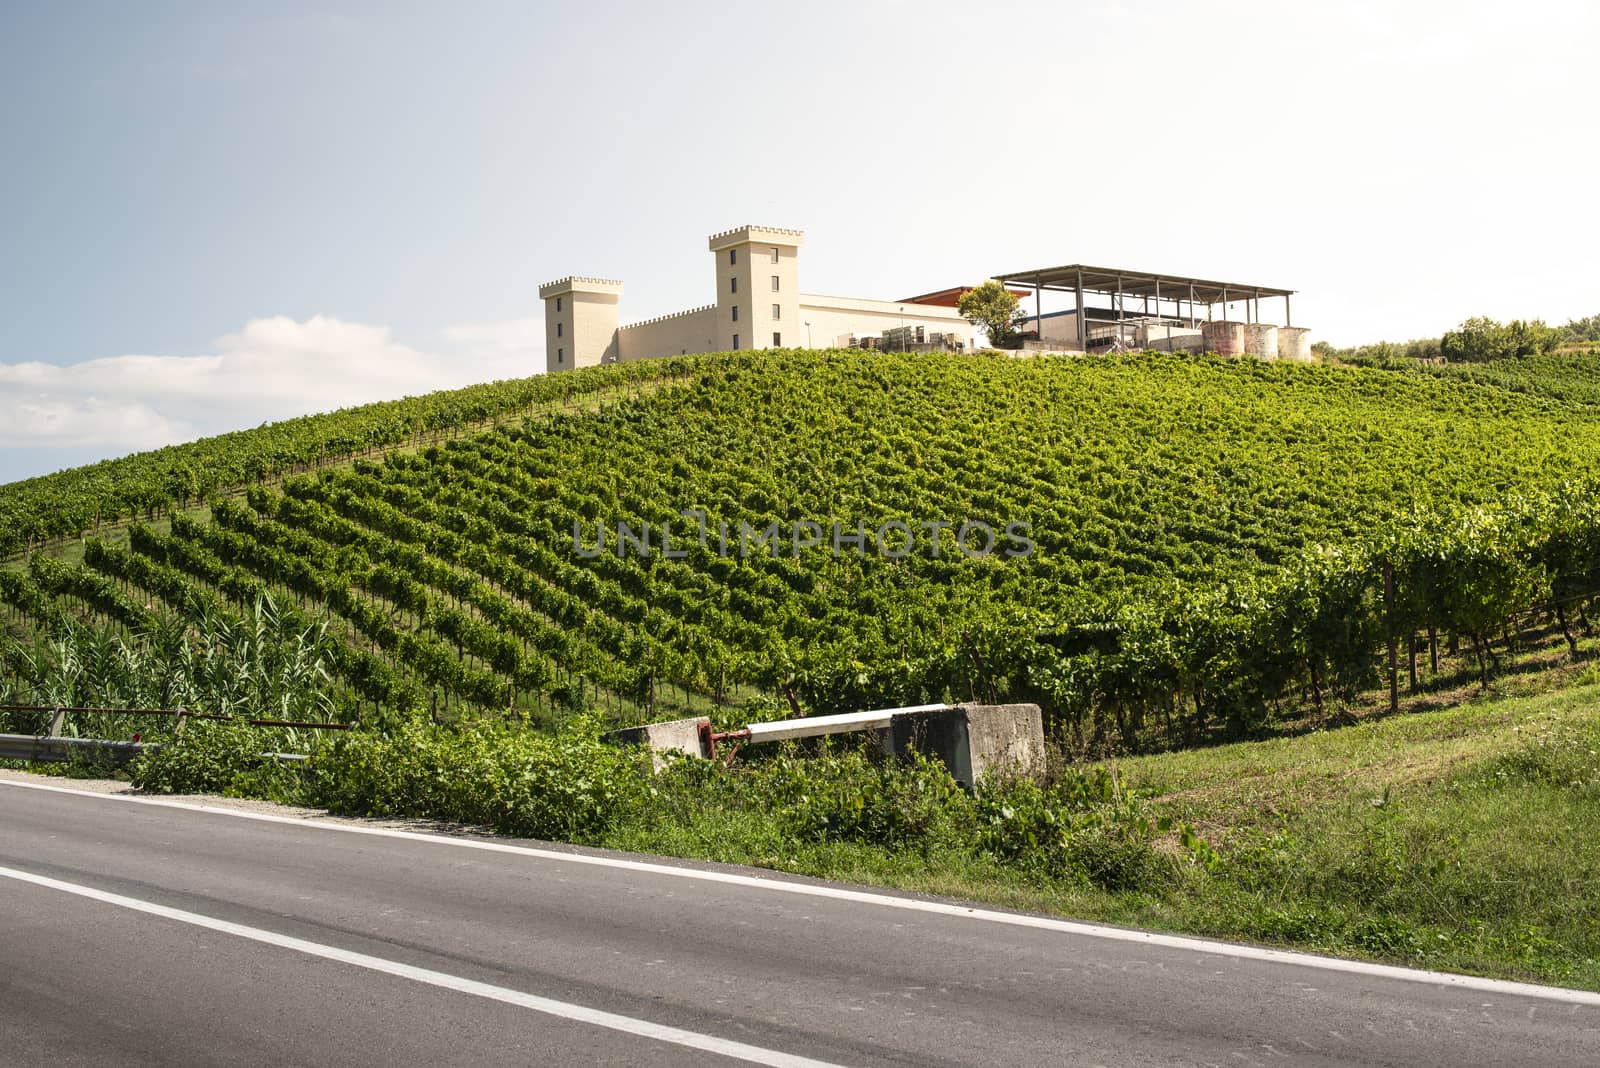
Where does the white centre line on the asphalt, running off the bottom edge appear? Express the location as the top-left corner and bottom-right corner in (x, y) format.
(0, 867), (840, 1068)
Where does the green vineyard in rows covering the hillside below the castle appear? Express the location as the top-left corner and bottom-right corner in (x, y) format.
(0, 352), (1600, 748)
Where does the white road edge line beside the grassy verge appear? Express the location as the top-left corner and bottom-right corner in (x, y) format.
(9, 777), (1600, 1007)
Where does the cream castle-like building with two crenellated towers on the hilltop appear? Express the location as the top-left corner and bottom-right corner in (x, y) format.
(539, 225), (978, 371)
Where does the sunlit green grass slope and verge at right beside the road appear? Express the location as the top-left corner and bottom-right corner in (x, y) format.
(605, 673), (1600, 990)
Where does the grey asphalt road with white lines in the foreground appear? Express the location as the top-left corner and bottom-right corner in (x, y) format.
(0, 779), (1600, 1068)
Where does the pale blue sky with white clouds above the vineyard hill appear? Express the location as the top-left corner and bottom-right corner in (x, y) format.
(0, 0), (1600, 481)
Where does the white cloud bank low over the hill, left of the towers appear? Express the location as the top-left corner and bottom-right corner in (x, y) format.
(0, 308), (544, 478)
